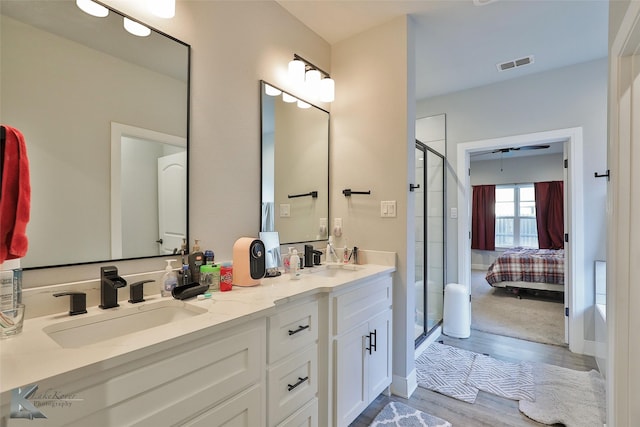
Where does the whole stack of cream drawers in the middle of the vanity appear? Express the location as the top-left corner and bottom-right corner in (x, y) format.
(267, 299), (318, 427)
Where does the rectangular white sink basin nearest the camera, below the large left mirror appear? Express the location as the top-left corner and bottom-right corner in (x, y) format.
(43, 300), (207, 348)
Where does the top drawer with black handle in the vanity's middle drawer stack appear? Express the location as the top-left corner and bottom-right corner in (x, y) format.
(268, 301), (318, 363)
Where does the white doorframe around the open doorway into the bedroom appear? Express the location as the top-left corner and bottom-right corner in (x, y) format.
(457, 127), (593, 354)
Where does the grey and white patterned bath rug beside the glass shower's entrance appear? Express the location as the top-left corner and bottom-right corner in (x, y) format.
(416, 343), (478, 403)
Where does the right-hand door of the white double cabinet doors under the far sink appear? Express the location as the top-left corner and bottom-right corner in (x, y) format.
(365, 310), (391, 400)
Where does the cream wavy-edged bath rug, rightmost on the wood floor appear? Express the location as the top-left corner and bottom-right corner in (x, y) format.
(518, 363), (606, 427)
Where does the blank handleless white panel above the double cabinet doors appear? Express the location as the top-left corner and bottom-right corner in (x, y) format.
(333, 276), (392, 335)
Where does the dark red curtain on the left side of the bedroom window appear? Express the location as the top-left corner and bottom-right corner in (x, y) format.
(471, 185), (496, 251)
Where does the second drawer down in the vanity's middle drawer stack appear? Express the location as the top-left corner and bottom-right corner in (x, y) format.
(267, 345), (318, 426)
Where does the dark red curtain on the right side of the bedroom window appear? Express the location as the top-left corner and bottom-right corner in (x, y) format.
(534, 181), (564, 249)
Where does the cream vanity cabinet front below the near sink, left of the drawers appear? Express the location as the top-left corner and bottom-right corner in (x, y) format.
(9, 318), (266, 427)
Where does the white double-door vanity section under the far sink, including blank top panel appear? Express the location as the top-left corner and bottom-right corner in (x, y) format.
(332, 276), (392, 427)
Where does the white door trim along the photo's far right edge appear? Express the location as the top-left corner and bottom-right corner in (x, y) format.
(606, 1), (640, 426)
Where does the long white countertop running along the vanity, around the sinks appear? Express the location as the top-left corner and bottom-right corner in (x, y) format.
(0, 264), (395, 393)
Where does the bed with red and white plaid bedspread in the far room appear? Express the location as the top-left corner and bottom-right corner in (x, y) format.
(486, 248), (564, 294)
